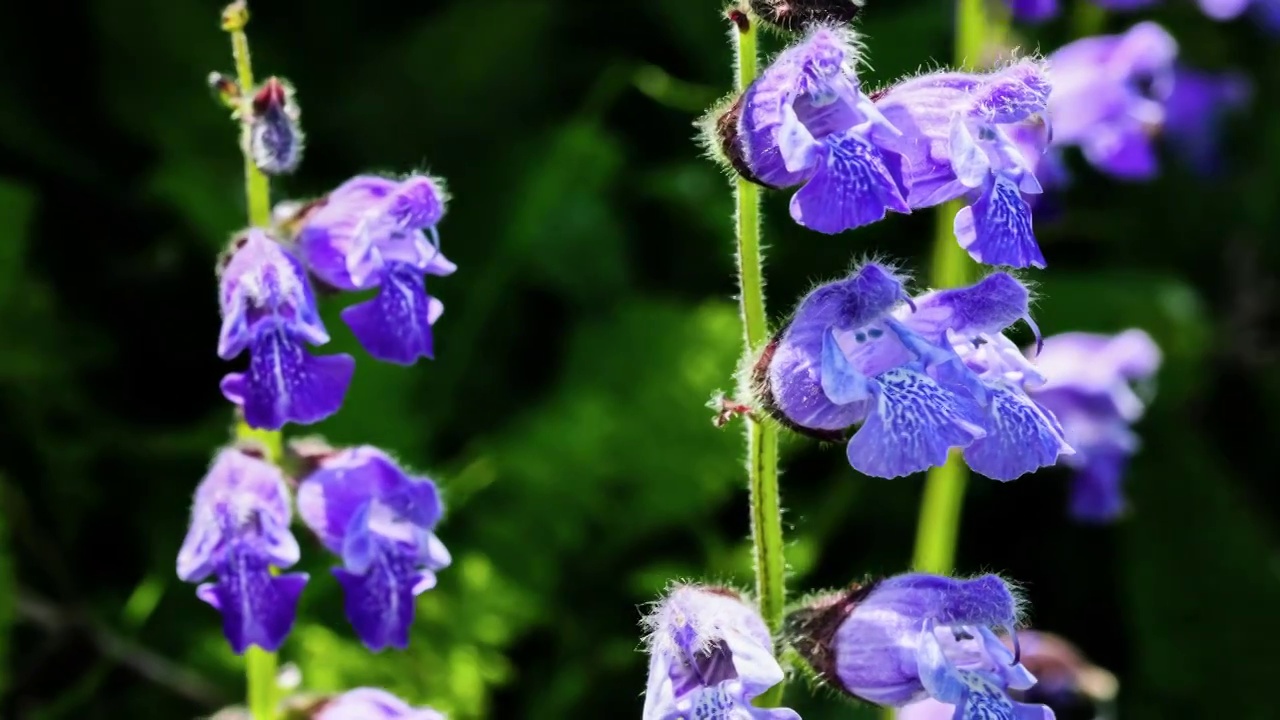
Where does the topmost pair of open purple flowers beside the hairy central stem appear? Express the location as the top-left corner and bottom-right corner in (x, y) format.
(714, 26), (1051, 268)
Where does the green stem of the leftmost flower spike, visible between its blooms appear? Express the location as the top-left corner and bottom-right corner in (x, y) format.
(223, 0), (277, 720)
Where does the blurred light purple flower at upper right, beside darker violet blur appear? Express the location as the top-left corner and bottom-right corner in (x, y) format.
(1048, 22), (1178, 179)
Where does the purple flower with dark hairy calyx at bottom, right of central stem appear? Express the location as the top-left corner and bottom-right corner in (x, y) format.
(786, 573), (1053, 720)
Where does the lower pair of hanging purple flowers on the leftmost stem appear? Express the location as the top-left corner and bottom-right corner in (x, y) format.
(178, 447), (449, 653)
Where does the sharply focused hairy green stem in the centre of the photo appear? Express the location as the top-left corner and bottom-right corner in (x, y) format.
(733, 10), (786, 707)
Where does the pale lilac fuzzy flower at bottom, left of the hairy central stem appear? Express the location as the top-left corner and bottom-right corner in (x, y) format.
(641, 585), (800, 720)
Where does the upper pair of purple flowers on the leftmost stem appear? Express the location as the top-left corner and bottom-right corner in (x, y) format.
(218, 170), (454, 429)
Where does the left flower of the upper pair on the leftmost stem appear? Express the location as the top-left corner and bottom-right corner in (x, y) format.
(218, 228), (356, 430)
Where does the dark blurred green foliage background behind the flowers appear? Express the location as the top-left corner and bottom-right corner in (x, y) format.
(0, 0), (1280, 720)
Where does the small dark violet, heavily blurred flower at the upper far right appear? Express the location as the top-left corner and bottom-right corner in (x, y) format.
(1164, 65), (1253, 174)
